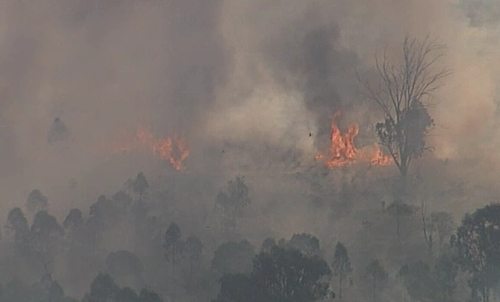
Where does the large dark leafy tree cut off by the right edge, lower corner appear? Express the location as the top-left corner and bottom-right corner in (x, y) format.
(452, 204), (500, 302)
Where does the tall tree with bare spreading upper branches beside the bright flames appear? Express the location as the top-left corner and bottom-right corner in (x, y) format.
(358, 36), (451, 178)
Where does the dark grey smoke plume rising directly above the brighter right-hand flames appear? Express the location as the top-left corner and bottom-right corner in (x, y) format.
(263, 13), (359, 134)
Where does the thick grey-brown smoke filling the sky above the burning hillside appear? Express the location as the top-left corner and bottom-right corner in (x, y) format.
(0, 0), (499, 218)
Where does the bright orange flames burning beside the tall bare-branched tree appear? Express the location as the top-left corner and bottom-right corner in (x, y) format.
(315, 111), (392, 169)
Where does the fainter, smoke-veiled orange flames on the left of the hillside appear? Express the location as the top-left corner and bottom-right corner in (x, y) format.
(94, 126), (189, 171)
